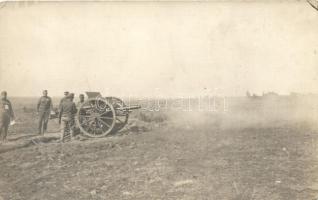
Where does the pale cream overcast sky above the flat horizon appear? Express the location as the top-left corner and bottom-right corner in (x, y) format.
(0, 1), (318, 96)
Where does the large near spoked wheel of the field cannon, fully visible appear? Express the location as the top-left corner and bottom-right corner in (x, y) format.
(76, 98), (116, 137)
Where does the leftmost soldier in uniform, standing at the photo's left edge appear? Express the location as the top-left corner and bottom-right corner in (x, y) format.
(0, 91), (14, 142)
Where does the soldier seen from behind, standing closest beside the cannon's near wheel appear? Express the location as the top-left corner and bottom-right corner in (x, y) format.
(59, 93), (77, 142)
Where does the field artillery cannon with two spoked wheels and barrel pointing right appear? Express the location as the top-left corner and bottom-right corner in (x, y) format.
(75, 92), (141, 137)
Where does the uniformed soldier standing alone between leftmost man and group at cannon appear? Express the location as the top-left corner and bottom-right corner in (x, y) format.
(37, 90), (53, 135)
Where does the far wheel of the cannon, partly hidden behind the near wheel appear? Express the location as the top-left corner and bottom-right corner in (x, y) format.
(106, 97), (129, 133)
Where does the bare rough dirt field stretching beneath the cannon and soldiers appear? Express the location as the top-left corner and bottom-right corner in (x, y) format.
(0, 97), (318, 200)
